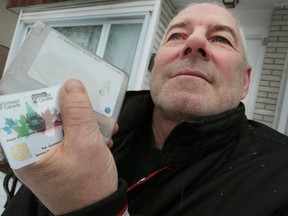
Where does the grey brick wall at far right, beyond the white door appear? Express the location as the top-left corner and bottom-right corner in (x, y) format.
(253, 5), (288, 127)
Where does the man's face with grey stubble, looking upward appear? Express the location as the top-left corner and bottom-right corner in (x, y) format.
(150, 4), (250, 119)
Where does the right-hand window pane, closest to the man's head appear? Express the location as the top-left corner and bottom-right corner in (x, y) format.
(104, 23), (142, 74)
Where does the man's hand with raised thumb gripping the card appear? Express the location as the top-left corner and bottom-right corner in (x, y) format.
(15, 80), (118, 215)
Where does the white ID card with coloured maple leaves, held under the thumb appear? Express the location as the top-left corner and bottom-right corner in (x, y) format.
(0, 86), (63, 169)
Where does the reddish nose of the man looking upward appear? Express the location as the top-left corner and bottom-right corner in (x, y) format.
(182, 32), (209, 60)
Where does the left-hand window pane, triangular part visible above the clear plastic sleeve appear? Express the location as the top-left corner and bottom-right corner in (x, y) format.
(54, 25), (102, 54)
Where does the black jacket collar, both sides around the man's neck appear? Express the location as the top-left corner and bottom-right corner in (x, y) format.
(116, 91), (248, 169)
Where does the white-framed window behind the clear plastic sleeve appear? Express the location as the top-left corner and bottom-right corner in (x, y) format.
(7, 5), (150, 89)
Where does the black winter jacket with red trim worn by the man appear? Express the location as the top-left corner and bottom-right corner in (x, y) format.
(3, 91), (288, 216)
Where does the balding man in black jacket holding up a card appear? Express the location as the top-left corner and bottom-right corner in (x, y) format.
(3, 3), (288, 216)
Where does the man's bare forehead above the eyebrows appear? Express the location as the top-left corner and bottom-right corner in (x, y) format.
(169, 3), (239, 33)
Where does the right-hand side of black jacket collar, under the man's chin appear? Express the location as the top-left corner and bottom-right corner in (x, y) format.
(159, 103), (248, 168)
